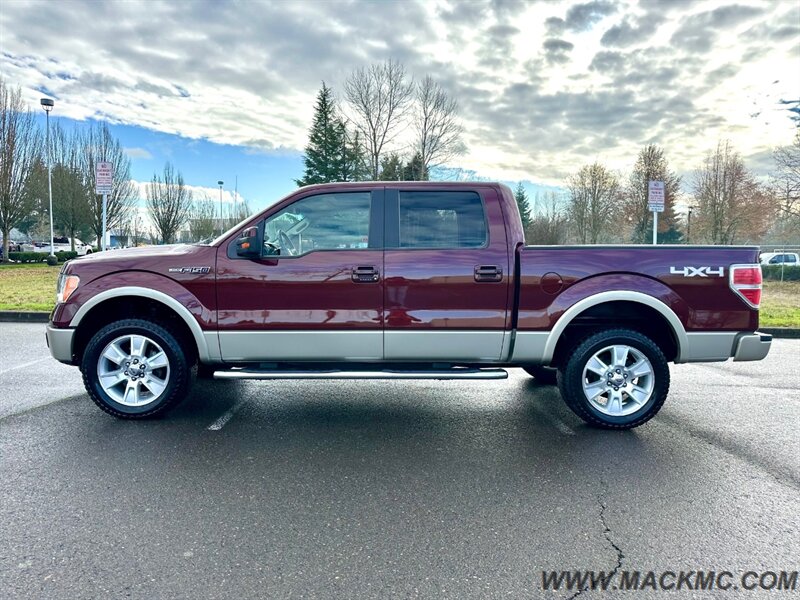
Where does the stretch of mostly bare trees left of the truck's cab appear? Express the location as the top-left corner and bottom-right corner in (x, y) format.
(0, 77), (249, 259)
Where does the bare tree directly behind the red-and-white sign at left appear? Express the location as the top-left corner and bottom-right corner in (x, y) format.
(81, 123), (136, 246)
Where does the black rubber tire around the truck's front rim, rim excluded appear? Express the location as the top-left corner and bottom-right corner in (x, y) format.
(81, 319), (191, 419)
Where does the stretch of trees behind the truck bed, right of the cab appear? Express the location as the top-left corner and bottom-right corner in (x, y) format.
(515, 132), (800, 244)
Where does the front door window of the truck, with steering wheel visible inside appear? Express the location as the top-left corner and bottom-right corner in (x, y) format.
(264, 192), (371, 256)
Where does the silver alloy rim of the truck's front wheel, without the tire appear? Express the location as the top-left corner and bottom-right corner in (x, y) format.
(97, 334), (169, 407)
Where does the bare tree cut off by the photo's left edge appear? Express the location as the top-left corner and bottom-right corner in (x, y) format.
(0, 77), (42, 260)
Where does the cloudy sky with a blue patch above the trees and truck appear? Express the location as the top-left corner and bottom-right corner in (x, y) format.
(0, 0), (800, 205)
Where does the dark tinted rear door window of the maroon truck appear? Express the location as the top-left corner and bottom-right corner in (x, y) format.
(400, 191), (488, 248)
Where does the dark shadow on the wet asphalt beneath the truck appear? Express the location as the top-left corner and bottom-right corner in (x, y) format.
(147, 380), (664, 480)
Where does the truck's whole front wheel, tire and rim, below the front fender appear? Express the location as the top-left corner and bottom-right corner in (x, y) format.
(81, 319), (191, 419)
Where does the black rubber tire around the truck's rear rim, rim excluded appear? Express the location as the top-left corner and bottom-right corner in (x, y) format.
(558, 329), (670, 429)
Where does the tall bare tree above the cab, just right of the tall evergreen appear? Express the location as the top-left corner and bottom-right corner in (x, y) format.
(344, 60), (414, 179)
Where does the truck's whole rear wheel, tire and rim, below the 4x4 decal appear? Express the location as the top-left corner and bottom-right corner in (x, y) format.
(558, 329), (669, 429)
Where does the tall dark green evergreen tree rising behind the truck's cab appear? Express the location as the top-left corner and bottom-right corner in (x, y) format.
(295, 81), (346, 186)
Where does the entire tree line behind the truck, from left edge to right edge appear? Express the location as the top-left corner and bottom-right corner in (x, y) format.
(0, 68), (800, 257)
